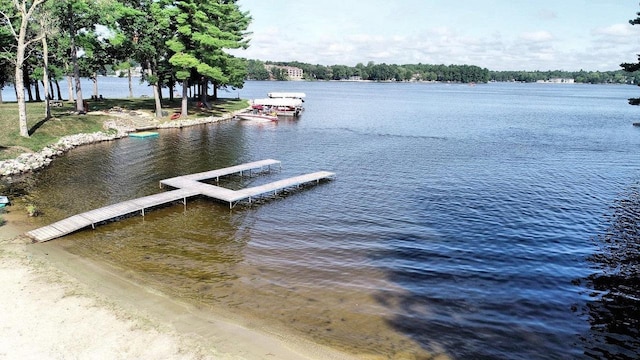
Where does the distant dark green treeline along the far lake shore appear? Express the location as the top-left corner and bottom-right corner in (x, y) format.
(247, 60), (640, 84)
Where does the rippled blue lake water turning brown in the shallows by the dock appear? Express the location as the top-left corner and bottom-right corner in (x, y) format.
(13, 80), (640, 359)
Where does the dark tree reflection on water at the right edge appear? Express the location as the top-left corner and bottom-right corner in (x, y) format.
(585, 184), (640, 359)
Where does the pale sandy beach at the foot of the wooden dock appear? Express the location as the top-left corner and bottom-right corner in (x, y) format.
(0, 210), (360, 360)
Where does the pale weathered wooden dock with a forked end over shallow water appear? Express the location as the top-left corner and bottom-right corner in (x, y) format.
(27, 159), (335, 242)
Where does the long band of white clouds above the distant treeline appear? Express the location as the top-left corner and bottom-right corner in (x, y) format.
(236, 17), (640, 71)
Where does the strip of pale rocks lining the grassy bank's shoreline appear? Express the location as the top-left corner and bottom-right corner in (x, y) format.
(0, 110), (244, 178)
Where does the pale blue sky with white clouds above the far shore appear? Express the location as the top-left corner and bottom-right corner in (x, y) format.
(232, 0), (640, 71)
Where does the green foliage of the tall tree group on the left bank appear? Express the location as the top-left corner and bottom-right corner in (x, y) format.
(0, 0), (251, 127)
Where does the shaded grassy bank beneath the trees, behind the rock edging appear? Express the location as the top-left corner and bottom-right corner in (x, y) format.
(0, 98), (248, 160)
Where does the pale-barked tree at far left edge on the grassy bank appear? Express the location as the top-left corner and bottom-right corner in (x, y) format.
(0, 0), (47, 137)
